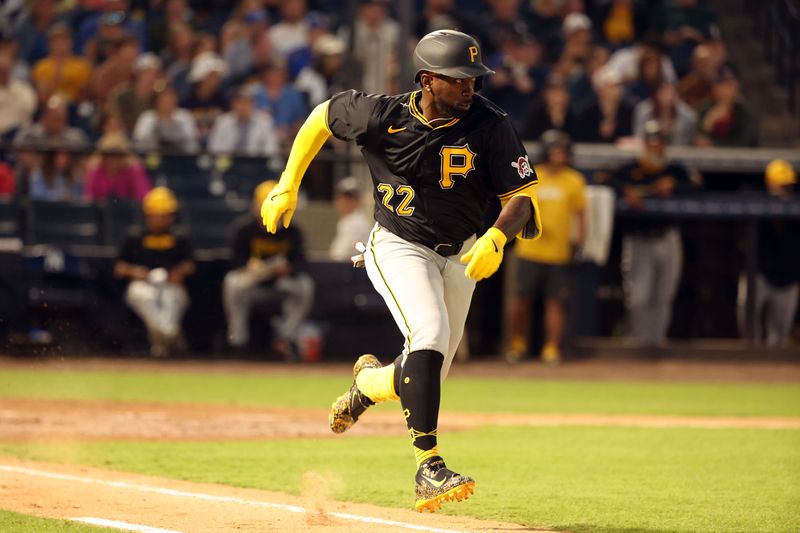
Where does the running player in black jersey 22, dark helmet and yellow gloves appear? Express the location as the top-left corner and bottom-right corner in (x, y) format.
(262, 30), (541, 512)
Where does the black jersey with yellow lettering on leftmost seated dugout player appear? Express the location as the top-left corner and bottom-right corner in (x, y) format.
(118, 231), (192, 270)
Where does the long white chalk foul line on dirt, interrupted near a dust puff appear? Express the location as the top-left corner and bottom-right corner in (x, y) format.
(0, 465), (464, 533)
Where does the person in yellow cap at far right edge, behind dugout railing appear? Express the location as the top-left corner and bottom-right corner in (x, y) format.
(737, 159), (800, 347)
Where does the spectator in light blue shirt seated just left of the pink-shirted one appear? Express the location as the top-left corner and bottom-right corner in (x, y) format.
(28, 146), (83, 201)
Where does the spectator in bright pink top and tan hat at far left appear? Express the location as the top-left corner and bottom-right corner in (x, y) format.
(84, 134), (152, 201)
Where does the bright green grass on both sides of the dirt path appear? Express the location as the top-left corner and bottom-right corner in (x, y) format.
(0, 370), (800, 533)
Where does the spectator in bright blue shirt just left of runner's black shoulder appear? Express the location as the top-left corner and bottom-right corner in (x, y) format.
(253, 60), (308, 148)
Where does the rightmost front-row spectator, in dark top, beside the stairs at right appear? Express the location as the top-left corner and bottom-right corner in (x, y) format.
(694, 67), (753, 146)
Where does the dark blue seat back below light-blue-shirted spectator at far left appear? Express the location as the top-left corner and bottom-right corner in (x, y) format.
(27, 200), (102, 246)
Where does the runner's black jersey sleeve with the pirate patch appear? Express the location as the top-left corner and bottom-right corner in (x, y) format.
(488, 116), (537, 200)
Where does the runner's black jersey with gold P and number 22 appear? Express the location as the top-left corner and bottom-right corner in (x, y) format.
(327, 91), (536, 247)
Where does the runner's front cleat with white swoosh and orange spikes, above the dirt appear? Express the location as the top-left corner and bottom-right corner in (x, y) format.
(414, 457), (475, 513)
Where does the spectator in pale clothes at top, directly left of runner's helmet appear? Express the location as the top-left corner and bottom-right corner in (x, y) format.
(340, 0), (400, 94)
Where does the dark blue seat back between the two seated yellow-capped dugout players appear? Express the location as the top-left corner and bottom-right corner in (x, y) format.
(183, 200), (250, 249)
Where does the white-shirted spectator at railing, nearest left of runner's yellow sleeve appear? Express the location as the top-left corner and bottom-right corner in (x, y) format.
(208, 87), (278, 157)
